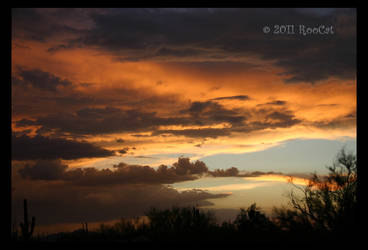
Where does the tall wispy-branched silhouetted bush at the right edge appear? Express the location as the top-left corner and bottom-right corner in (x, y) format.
(290, 149), (357, 231)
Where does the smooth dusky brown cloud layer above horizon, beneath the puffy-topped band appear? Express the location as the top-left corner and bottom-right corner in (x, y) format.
(12, 175), (228, 225)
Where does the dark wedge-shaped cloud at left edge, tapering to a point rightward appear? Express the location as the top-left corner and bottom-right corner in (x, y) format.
(11, 134), (114, 160)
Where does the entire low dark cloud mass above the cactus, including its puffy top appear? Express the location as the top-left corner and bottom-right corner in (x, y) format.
(12, 158), (229, 225)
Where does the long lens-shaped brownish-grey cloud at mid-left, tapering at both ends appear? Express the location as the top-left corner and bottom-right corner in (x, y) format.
(16, 107), (191, 134)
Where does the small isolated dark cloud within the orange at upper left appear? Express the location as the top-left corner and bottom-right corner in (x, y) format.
(12, 69), (72, 91)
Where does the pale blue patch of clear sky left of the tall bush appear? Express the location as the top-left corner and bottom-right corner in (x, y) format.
(200, 137), (356, 174)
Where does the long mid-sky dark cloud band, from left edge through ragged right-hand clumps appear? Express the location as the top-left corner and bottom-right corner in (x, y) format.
(15, 97), (301, 138)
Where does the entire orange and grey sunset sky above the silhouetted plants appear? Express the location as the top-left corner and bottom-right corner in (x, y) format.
(11, 8), (356, 233)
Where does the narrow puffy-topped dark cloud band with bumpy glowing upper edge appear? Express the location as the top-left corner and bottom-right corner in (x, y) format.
(19, 158), (213, 186)
